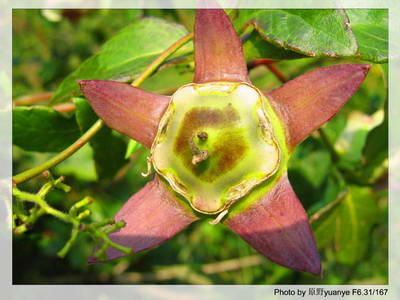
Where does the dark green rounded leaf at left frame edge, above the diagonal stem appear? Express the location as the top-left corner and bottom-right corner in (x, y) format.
(12, 106), (80, 152)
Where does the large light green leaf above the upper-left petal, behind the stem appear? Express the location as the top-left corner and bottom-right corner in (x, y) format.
(52, 18), (191, 102)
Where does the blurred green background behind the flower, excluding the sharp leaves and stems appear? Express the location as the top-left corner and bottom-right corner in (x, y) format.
(13, 10), (388, 284)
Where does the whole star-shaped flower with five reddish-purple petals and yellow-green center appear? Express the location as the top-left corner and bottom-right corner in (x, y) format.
(80, 9), (369, 275)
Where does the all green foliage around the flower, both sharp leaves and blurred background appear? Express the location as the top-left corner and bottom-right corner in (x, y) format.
(13, 10), (388, 284)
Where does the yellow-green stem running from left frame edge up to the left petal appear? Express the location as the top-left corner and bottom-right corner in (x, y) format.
(12, 120), (103, 184)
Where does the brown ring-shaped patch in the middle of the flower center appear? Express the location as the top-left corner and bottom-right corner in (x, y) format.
(174, 104), (248, 182)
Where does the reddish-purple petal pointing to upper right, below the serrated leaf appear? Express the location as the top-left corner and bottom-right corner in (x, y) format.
(266, 64), (370, 149)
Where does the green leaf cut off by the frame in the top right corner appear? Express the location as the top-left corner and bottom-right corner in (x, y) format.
(346, 9), (389, 63)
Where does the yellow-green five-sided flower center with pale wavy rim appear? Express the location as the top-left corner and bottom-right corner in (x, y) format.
(151, 82), (280, 214)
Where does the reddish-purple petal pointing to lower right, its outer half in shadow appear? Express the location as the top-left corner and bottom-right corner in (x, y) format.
(224, 174), (321, 275)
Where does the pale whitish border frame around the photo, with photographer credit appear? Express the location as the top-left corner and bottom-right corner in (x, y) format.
(0, 0), (400, 300)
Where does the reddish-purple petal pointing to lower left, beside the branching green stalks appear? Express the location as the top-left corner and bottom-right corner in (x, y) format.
(101, 176), (197, 259)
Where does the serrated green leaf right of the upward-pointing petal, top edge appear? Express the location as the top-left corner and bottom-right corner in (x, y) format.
(239, 9), (357, 56)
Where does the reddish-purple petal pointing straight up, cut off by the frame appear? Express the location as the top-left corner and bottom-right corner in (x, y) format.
(194, 9), (249, 83)
